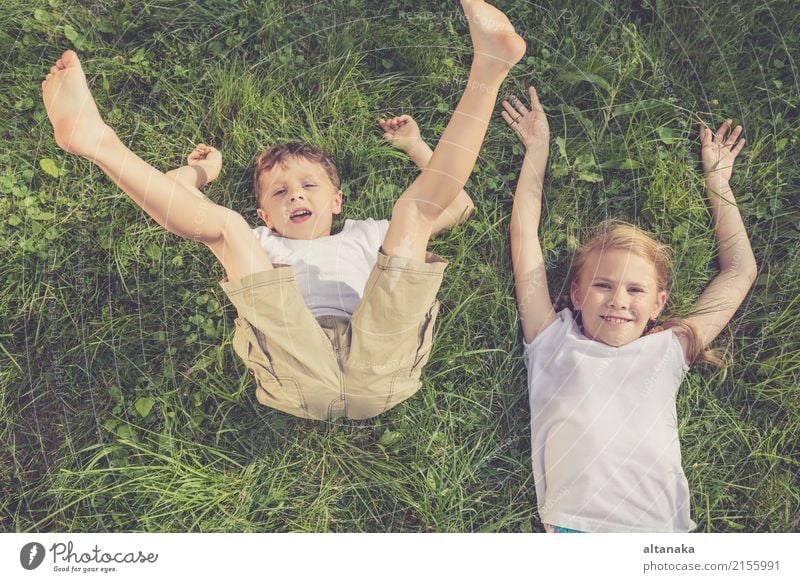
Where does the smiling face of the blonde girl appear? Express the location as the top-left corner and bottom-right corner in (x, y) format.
(570, 249), (667, 346)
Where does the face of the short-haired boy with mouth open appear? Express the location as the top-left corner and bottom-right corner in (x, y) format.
(258, 157), (342, 240)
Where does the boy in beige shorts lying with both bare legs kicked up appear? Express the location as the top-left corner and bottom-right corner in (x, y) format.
(42, 0), (525, 420)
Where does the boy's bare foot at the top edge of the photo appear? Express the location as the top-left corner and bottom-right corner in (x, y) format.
(461, 0), (526, 72)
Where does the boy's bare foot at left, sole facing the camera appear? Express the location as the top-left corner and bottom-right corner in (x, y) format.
(42, 51), (113, 160)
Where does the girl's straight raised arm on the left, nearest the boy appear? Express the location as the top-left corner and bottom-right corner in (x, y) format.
(502, 87), (556, 343)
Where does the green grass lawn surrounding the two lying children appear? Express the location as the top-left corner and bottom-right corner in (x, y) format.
(0, 0), (800, 532)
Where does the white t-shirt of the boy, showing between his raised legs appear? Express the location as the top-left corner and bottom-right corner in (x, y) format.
(252, 218), (389, 317)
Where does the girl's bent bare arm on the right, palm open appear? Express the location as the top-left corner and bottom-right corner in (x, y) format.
(679, 119), (758, 356)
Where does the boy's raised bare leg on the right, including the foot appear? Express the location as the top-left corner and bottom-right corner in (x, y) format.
(383, 0), (525, 260)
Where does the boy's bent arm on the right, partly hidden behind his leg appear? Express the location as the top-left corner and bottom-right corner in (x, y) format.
(378, 115), (475, 234)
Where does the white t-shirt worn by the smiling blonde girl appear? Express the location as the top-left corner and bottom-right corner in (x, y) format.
(523, 309), (696, 532)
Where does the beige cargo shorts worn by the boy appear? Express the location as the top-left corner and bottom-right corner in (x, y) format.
(220, 252), (447, 420)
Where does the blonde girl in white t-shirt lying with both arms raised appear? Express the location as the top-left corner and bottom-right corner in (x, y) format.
(502, 87), (757, 532)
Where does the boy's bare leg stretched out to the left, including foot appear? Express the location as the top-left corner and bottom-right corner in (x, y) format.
(42, 51), (272, 280)
